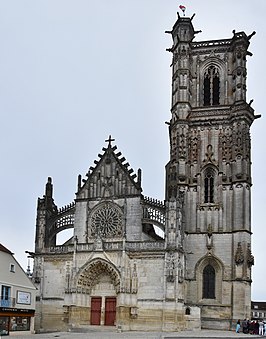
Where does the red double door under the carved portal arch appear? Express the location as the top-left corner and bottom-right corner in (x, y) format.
(91, 297), (116, 326)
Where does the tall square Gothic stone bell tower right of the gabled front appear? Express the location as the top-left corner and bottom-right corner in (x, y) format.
(165, 15), (259, 328)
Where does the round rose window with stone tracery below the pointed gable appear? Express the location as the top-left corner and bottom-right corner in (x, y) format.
(91, 204), (122, 237)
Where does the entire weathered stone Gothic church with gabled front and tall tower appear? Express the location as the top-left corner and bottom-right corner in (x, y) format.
(32, 11), (258, 331)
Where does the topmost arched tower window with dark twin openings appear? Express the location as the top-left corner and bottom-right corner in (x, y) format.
(203, 66), (220, 106)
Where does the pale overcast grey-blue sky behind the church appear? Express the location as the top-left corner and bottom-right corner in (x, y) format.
(0, 0), (266, 300)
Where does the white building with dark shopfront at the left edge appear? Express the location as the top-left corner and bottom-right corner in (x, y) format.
(0, 244), (36, 335)
